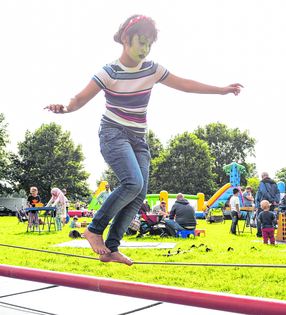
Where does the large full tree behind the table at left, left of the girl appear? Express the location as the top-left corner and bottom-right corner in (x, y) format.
(12, 123), (90, 202)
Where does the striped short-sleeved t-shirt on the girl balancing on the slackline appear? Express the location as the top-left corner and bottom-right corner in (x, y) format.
(93, 60), (169, 134)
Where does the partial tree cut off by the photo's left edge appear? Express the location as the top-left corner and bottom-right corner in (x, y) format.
(0, 113), (11, 194)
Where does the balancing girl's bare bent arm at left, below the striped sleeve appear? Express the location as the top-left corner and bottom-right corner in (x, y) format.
(44, 80), (101, 114)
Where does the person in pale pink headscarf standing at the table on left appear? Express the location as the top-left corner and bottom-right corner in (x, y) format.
(46, 188), (66, 231)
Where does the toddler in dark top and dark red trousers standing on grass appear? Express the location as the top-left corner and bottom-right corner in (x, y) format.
(257, 200), (276, 245)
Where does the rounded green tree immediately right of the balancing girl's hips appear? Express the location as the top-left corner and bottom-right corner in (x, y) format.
(150, 132), (216, 196)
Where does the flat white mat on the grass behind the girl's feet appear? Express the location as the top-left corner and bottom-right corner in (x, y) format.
(54, 240), (177, 249)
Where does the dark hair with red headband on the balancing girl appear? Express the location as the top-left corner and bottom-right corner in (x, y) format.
(113, 14), (158, 44)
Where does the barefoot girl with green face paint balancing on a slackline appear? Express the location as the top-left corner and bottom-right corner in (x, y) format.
(46, 15), (242, 265)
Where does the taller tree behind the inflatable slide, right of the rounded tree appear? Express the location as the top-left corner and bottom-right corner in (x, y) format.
(194, 123), (256, 187)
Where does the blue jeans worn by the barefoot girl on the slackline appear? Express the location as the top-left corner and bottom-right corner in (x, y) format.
(88, 125), (150, 252)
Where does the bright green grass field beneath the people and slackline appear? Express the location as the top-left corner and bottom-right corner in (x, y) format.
(0, 217), (286, 300)
